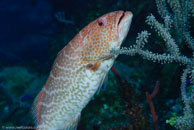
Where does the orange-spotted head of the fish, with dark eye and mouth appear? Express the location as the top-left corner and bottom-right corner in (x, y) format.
(81, 11), (133, 61)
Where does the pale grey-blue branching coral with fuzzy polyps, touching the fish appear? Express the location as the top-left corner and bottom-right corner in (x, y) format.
(111, 0), (194, 130)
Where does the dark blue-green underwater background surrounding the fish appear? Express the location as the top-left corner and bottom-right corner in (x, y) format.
(0, 0), (194, 130)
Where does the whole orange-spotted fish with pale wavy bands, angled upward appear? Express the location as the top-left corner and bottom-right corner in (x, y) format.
(33, 11), (132, 130)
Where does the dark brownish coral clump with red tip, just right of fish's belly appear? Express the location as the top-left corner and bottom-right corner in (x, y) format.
(111, 67), (149, 130)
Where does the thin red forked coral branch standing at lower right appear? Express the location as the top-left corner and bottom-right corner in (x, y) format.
(146, 81), (159, 130)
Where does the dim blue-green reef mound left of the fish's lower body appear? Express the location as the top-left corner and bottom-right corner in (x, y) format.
(0, 66), (47, 126)
